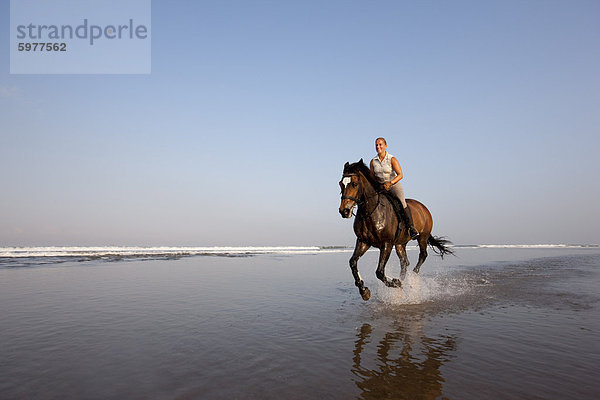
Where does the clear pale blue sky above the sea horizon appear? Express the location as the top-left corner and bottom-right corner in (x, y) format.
(0, 0), (600, 246)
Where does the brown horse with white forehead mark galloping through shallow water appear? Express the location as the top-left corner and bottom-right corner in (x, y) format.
(340, 159), (454, 300)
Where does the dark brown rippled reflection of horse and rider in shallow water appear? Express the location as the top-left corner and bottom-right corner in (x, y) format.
(352, 319), (456, 400)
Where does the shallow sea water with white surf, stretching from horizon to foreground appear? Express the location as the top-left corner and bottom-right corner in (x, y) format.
(0, 245), (600, 399)
